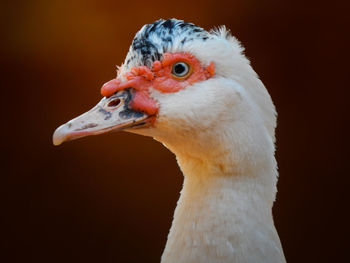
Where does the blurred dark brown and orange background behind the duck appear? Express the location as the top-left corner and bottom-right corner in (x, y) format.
(0, 0), (350, 263)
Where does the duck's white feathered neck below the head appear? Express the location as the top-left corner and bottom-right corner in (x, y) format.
(162, 150), (285, 263)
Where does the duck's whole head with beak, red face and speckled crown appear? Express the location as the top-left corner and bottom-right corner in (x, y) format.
(53, 19), (275, 164)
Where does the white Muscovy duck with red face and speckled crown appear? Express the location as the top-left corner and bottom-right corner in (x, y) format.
(53, 18), (286, 263)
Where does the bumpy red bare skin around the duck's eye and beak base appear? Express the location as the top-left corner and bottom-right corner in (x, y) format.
(101, 52), (215, 116)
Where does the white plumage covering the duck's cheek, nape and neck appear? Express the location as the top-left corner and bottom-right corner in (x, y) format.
(126, 22), (285, 263)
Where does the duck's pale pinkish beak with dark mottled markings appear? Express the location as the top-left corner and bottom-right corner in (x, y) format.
(53, 88), (153, 145)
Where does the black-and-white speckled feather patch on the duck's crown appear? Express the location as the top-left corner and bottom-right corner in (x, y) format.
(125, 19), (210, 68)
